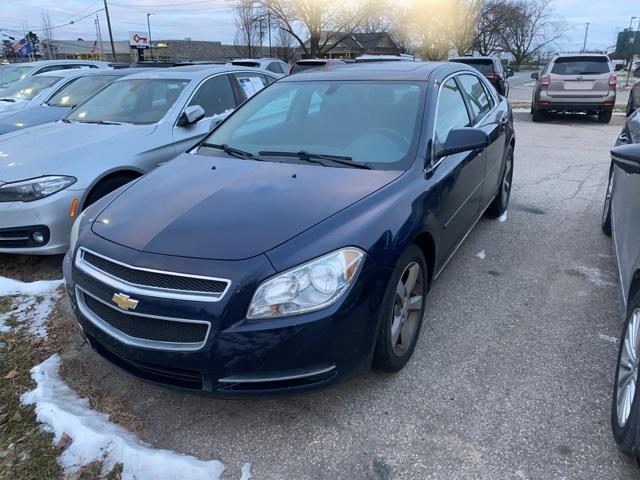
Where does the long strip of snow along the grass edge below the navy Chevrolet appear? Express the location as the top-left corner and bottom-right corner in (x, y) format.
(22, 355), (226, 480)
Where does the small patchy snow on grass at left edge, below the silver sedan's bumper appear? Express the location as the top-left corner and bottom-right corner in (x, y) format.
(0, 277), (63, 337)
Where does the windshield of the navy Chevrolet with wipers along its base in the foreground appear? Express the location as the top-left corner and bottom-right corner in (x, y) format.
(203, 81), (425, 170)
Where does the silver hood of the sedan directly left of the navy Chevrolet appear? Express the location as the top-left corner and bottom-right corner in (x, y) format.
(0, 120), (156, 182)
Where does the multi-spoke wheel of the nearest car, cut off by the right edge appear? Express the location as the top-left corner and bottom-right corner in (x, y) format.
(611, 292), (640, 455)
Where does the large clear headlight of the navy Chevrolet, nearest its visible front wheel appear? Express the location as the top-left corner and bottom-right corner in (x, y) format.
(247, 247), (364, 319)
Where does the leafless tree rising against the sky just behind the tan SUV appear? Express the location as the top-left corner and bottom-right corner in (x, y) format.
(498, 0), (567, 68)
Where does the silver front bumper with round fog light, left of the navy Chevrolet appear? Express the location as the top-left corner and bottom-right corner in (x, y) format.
(0, 190), (82, 255)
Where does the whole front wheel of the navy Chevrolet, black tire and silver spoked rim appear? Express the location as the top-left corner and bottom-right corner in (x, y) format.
(373, 245), (429, 372)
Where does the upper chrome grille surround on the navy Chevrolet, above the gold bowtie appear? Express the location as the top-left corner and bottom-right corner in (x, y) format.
(74, 247), (231, 302)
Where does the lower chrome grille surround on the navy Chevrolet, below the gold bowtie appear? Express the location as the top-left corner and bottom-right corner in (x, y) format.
(76, 285), (211, 352)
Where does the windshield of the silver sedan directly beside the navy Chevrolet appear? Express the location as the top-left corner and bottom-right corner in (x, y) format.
(66, 78), (189, 124)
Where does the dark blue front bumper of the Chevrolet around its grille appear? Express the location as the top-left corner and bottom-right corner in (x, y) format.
(63, 239), (389, 397)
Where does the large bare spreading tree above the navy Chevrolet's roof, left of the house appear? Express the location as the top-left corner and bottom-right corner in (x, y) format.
(257, 0), (370, 58)
